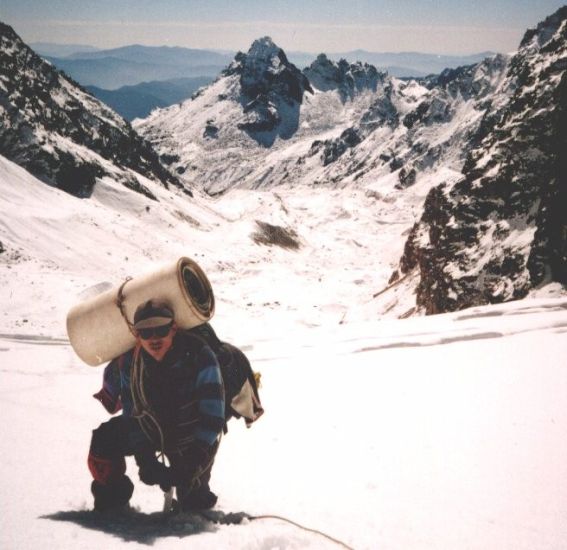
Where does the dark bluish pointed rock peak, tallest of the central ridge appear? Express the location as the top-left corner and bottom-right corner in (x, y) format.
(222, 37), (313, 147)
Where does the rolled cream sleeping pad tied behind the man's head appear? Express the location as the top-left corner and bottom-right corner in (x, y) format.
(67, 258), (215, 367)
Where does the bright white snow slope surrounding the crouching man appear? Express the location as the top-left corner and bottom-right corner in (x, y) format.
(0, 152), (567, 550)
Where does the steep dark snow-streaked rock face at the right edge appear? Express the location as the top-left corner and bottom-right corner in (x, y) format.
(400, 7), (567, 313)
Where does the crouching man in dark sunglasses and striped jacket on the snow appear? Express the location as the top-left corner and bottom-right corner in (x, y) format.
(88, 300), (225, 511)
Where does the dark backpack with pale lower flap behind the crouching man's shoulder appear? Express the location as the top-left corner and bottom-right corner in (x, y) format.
(188, 323), (264, 427)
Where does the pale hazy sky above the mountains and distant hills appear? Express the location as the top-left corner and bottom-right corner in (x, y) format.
(0, 0), (565, 54)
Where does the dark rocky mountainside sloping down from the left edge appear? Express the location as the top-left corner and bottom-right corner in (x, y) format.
(0, 23), (180, 198)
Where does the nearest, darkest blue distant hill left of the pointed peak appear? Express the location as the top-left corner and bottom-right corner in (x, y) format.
(86, 76), (212, 121)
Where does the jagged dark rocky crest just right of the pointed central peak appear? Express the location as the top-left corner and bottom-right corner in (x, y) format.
(303, 54), (386, 102)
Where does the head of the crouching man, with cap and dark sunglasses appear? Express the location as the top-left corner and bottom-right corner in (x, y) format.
(134, 300), (177, 361)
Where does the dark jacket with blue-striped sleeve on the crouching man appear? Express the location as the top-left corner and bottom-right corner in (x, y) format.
(95, 330), (225, 454)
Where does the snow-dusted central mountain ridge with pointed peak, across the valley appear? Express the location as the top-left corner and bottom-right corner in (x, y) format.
(134, 38), (505, 198)
